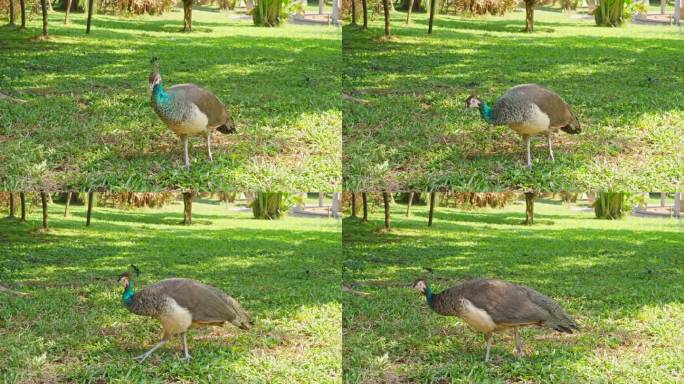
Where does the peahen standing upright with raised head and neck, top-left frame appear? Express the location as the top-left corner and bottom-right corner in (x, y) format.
(150, 57), (235, 167)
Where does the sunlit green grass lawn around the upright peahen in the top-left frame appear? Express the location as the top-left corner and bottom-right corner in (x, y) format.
(0, 7), (342, 191)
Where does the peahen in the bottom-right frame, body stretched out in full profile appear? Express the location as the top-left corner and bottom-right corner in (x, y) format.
(413, 279), (579, 362)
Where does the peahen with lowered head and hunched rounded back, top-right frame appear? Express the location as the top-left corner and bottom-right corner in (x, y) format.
(465, 84), (581, 168)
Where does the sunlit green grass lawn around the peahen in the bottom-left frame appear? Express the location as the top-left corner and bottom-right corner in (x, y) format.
(0, 200), (342, 383)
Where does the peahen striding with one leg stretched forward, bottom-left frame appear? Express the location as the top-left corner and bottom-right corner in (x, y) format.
(119, 266), (254, 362)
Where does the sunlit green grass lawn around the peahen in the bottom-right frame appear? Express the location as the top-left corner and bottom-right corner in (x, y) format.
(342, 200), (684, 383)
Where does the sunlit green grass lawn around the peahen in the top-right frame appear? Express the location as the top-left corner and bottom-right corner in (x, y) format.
(342, 8), (684, 191)
